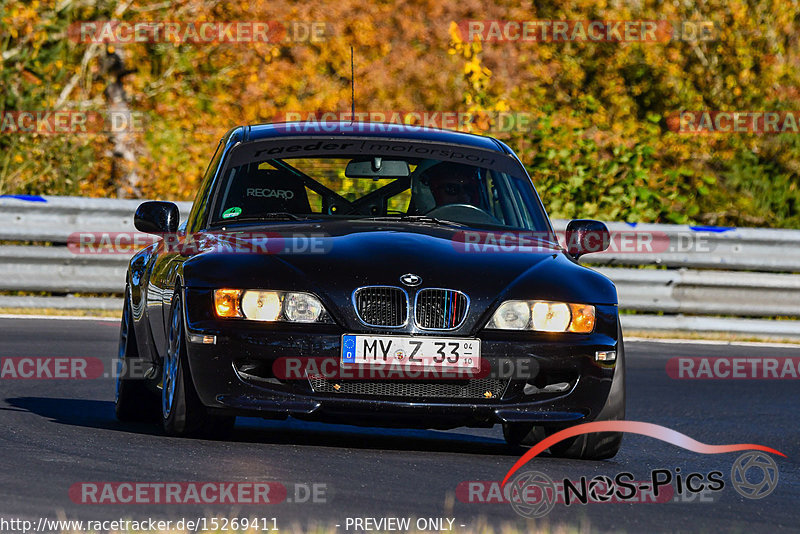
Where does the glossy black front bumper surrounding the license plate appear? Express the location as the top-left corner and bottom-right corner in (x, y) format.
(181, 290), (617, 428)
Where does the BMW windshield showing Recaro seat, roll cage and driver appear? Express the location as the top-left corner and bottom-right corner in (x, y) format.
(210, 141), (549, 232)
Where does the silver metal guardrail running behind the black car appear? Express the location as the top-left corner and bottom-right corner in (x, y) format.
(0, 197), (800, 338)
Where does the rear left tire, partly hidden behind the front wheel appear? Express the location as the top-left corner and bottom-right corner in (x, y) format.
(114, 288), (158, 421)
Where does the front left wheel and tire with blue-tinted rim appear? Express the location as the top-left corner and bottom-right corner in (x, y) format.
(161, 292), (236, 439)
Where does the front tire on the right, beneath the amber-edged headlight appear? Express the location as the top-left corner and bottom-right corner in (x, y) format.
(546, 320), (625, 460)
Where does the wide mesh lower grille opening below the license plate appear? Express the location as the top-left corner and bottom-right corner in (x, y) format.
(309, 377), (508, 400)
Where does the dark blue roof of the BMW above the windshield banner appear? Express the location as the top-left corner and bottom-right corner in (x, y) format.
(238, 122), (512, 154)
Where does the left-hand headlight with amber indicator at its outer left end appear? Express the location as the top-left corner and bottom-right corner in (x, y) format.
(214, 289), (333, 323)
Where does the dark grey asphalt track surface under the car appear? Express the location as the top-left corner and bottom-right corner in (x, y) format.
(0, 318), (800, 532)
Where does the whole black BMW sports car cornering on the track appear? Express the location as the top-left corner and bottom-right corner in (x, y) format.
(116, 123), (625, 459)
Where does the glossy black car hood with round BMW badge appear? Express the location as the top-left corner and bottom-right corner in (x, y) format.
(183, 221), (617, 327)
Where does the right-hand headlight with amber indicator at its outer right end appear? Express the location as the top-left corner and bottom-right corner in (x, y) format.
(486, 300), (595, 334)
